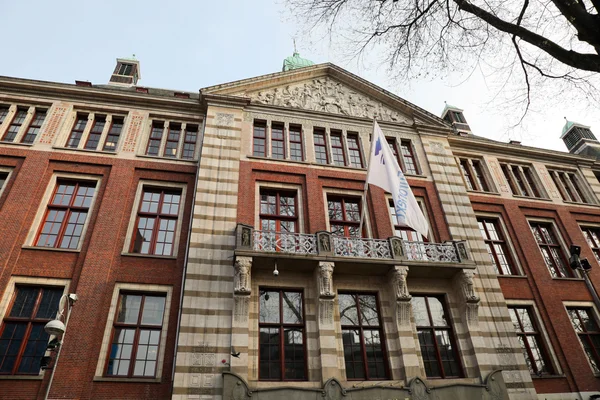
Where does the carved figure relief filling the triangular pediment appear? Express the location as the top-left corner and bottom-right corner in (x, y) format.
(249, 77), (412, 124)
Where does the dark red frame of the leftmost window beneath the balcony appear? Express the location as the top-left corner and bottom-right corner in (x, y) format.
(257, 286), (308, 382)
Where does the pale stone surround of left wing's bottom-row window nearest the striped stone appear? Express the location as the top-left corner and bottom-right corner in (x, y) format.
(94, 283), (173, 382)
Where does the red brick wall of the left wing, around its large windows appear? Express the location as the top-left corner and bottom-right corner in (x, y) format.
(0, 147), (196, 400)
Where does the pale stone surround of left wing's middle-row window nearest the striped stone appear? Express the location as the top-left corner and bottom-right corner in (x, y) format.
(121, 179), (191, 258)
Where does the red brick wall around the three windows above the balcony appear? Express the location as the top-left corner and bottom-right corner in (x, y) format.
(237, 161), (450, 242)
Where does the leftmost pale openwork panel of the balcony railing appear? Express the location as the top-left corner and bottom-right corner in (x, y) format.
(254, 231), (317, 255)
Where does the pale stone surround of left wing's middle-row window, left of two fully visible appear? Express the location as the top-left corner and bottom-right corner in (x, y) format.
(23, 172), (102, 252)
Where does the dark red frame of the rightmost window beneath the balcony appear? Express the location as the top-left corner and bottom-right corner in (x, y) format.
(411, 293), (465, 379)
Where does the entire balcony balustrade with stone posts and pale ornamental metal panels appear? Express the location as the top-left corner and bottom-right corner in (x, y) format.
(235, 224), (475, 274)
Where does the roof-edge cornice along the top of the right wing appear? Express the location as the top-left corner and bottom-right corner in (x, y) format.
(448, 136), (596, 167)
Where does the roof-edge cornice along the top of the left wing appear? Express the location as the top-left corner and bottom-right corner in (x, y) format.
(0, 76), (204, 114)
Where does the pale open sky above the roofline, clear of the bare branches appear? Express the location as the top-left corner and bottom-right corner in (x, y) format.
(0, 0), (600, 150)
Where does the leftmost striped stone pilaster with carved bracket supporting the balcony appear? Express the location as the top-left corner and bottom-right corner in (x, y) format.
(230, 257), (252, 380)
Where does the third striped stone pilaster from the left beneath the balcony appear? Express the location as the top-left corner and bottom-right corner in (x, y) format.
(389, 265), (421, 382)
